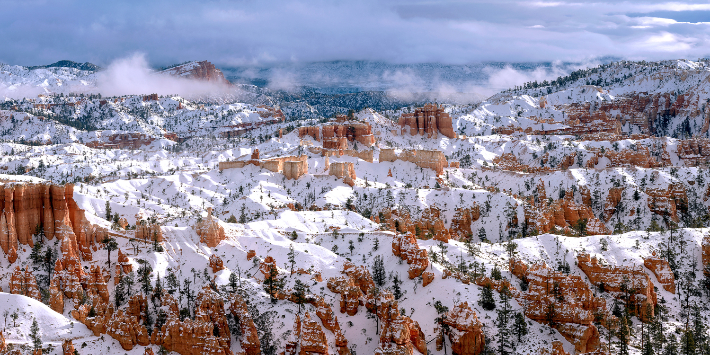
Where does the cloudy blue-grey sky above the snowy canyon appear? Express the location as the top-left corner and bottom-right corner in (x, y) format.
(0, 0), (710, 66)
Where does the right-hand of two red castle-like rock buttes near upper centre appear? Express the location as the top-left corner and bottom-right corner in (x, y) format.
(399, 104), (456, 138)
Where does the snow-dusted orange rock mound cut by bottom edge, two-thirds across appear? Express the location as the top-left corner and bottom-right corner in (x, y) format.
(436, 302), (485, 355)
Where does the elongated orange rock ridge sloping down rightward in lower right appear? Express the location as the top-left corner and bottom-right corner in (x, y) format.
(577, 254), (657, 321)
